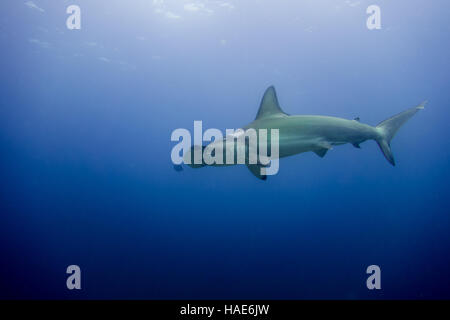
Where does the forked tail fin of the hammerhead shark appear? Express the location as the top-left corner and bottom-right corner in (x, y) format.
(376, 101), (426, 166)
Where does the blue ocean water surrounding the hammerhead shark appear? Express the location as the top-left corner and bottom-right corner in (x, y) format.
(0, 0), (450, 299)
